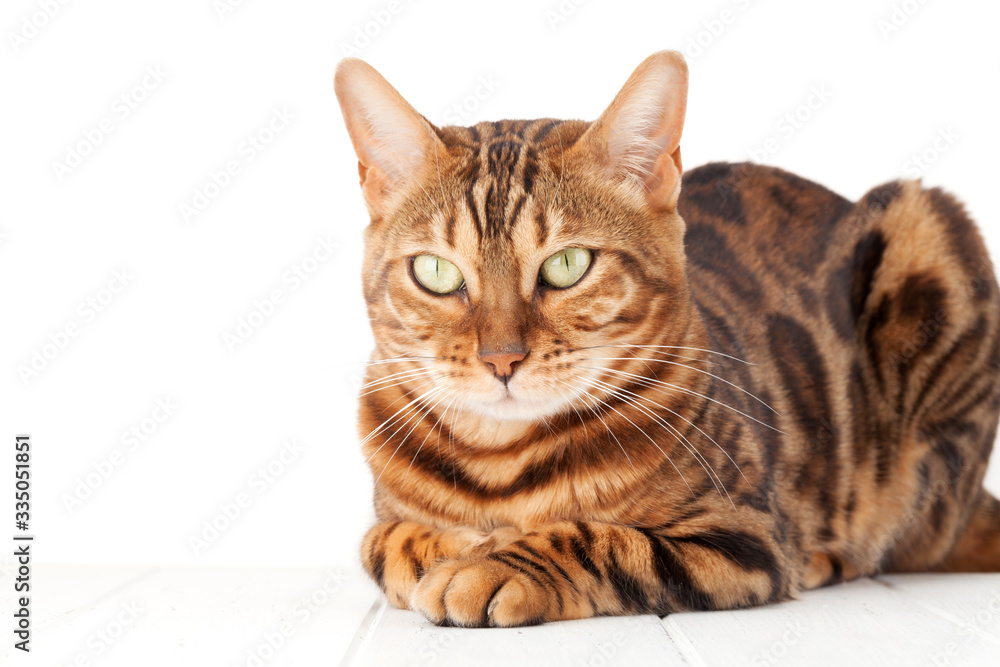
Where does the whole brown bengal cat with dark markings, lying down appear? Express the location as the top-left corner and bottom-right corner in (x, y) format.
(335, 52), (1000, 627)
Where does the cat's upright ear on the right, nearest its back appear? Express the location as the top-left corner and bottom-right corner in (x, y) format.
(577, 51), (688, 210)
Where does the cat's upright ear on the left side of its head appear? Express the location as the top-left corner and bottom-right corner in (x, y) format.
(333, 58), (443, 217)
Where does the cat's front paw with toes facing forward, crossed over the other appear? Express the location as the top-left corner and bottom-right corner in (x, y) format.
(410, 557), (552, 628)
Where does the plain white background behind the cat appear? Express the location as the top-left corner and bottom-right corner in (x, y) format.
(0, 0), (1000, 565)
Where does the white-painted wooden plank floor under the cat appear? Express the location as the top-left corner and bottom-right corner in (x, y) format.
(7, 564), (1000, 667)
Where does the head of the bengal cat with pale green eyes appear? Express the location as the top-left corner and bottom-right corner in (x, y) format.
(335, 51), (690, 430)
